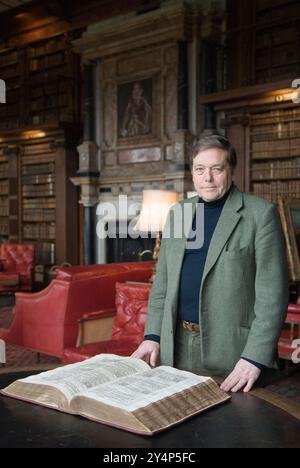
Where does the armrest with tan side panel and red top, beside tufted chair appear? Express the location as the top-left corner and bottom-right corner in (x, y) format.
(76, 308), (117, 347)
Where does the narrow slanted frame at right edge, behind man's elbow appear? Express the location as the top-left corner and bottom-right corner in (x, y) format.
(278, 197), (300, 282)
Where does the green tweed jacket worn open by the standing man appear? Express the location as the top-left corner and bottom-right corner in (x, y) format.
(145, 187), (288, 375)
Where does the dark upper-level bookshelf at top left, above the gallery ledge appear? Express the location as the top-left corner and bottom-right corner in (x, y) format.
(0, 35), (80, 131)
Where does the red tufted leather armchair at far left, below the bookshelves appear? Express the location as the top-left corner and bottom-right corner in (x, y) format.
(0, 243), (34, 292)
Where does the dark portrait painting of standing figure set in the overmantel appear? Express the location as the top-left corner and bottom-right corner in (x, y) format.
(117, 78), (153, 138)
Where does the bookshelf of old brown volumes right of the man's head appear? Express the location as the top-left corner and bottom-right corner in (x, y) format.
(250, 108), (300, 203)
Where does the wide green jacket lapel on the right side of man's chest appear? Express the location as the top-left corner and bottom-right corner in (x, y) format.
(202, 187), (243, 284)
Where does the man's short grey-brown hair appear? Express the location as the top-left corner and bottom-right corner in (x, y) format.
(190, 135), (237, 172)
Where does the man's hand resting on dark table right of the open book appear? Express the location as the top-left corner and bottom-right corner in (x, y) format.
(221, 359), (261, 393)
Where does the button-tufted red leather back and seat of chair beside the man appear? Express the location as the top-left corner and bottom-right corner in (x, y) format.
(63, 283), (151, 362)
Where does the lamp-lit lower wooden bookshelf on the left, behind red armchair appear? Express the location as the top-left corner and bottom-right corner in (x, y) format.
(0, 125), (80, 282)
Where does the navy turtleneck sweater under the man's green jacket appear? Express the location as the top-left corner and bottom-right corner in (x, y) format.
(178, 185), (233, 323)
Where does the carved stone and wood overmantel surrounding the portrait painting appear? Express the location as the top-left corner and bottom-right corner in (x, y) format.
(72, 0), (225, 264)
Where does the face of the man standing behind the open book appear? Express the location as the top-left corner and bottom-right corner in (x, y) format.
(192, 148), (233, 202)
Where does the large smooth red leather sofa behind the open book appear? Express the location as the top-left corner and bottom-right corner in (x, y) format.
(0, 261), (153, 358)
